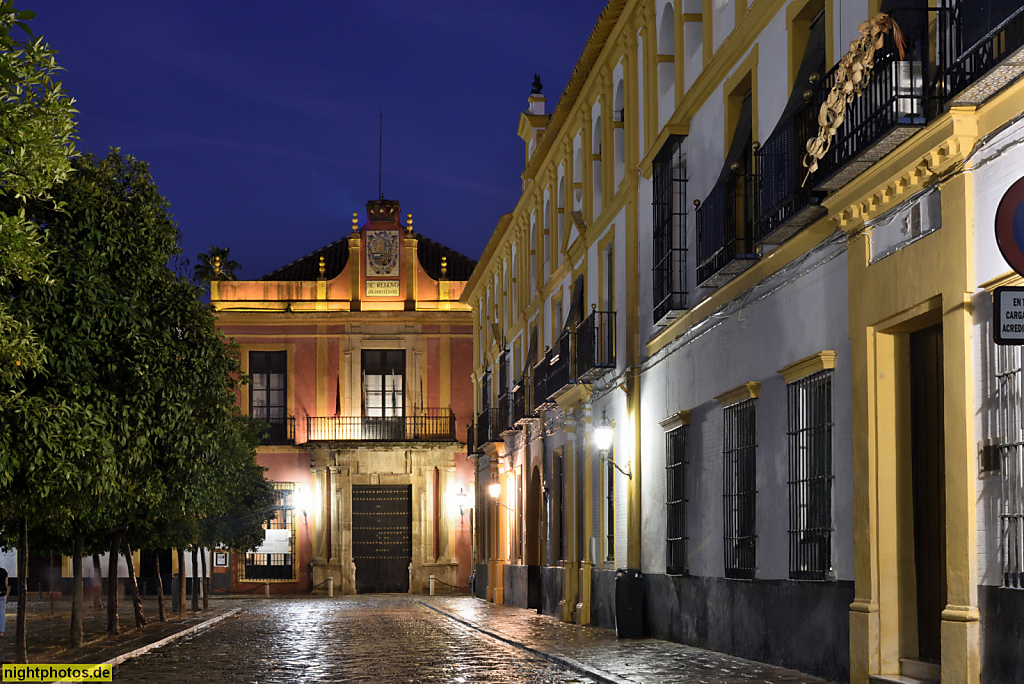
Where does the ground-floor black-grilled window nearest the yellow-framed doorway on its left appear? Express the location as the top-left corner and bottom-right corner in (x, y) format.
(786, 371), (833, 580)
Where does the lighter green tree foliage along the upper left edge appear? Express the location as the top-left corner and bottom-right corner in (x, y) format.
(0, 0), (77, 387)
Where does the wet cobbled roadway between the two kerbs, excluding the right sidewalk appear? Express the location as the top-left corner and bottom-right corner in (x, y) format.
(124, 595), (595, 684)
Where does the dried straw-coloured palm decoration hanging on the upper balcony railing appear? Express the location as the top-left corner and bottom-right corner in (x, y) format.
(801, 12), (906, 186)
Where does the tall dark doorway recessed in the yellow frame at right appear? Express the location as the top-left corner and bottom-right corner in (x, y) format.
(909, 326), (946, 661)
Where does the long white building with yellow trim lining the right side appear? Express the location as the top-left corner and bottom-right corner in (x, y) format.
(462, 0), (1024, 682)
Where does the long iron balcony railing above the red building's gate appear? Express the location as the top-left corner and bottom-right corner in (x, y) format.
(306, 409), (457, 441)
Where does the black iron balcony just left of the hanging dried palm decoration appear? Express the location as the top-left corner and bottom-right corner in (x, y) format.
(754, 100), (826, 245)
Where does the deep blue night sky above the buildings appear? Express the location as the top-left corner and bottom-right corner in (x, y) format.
(28, 0), (604, 279)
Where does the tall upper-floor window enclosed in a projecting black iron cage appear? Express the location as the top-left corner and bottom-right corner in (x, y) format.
(655, 135), (686, 324)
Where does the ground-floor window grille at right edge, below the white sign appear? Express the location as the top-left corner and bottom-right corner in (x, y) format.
(995, 345), (1024, 589)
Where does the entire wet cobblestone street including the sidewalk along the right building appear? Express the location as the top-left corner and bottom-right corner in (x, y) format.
(115, 595), (821, 684)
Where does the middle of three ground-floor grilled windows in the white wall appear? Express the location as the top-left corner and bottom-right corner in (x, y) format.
(722, 399), (758, 580)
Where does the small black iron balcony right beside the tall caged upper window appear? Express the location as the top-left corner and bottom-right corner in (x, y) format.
(696, 173), (758, 288)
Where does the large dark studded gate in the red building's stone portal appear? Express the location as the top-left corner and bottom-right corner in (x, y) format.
(352, 484), (413, 594)
